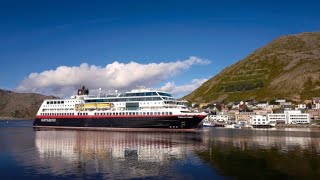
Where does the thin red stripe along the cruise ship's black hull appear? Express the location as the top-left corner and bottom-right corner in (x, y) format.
(36, 115), (206, 119)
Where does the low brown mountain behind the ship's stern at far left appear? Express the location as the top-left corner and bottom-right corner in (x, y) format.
(0, 89), (56, 119)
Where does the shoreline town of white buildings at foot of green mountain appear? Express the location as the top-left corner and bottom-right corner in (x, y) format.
(191, 97), (320, 128)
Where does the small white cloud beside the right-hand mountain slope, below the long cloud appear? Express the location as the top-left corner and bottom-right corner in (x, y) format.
(160, 78), (208, 97)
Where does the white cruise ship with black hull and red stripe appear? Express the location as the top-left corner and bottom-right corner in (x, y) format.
(33, 86), (207, 131)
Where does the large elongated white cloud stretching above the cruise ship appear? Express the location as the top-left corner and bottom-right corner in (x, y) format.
(16, 56), (210, 96)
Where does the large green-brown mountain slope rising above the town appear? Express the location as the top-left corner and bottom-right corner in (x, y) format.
(184, 32), (320, 102)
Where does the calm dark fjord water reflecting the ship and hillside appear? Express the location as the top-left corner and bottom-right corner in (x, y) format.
(0, 120), (320, 179)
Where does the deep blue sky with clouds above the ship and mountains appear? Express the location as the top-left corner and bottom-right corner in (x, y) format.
(0, 0), (320, 95)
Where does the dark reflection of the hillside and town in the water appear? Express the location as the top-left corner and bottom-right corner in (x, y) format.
(196, 129), (320, 179)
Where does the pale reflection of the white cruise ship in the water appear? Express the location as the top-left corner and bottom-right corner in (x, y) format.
(35, 131), (205, 178)
